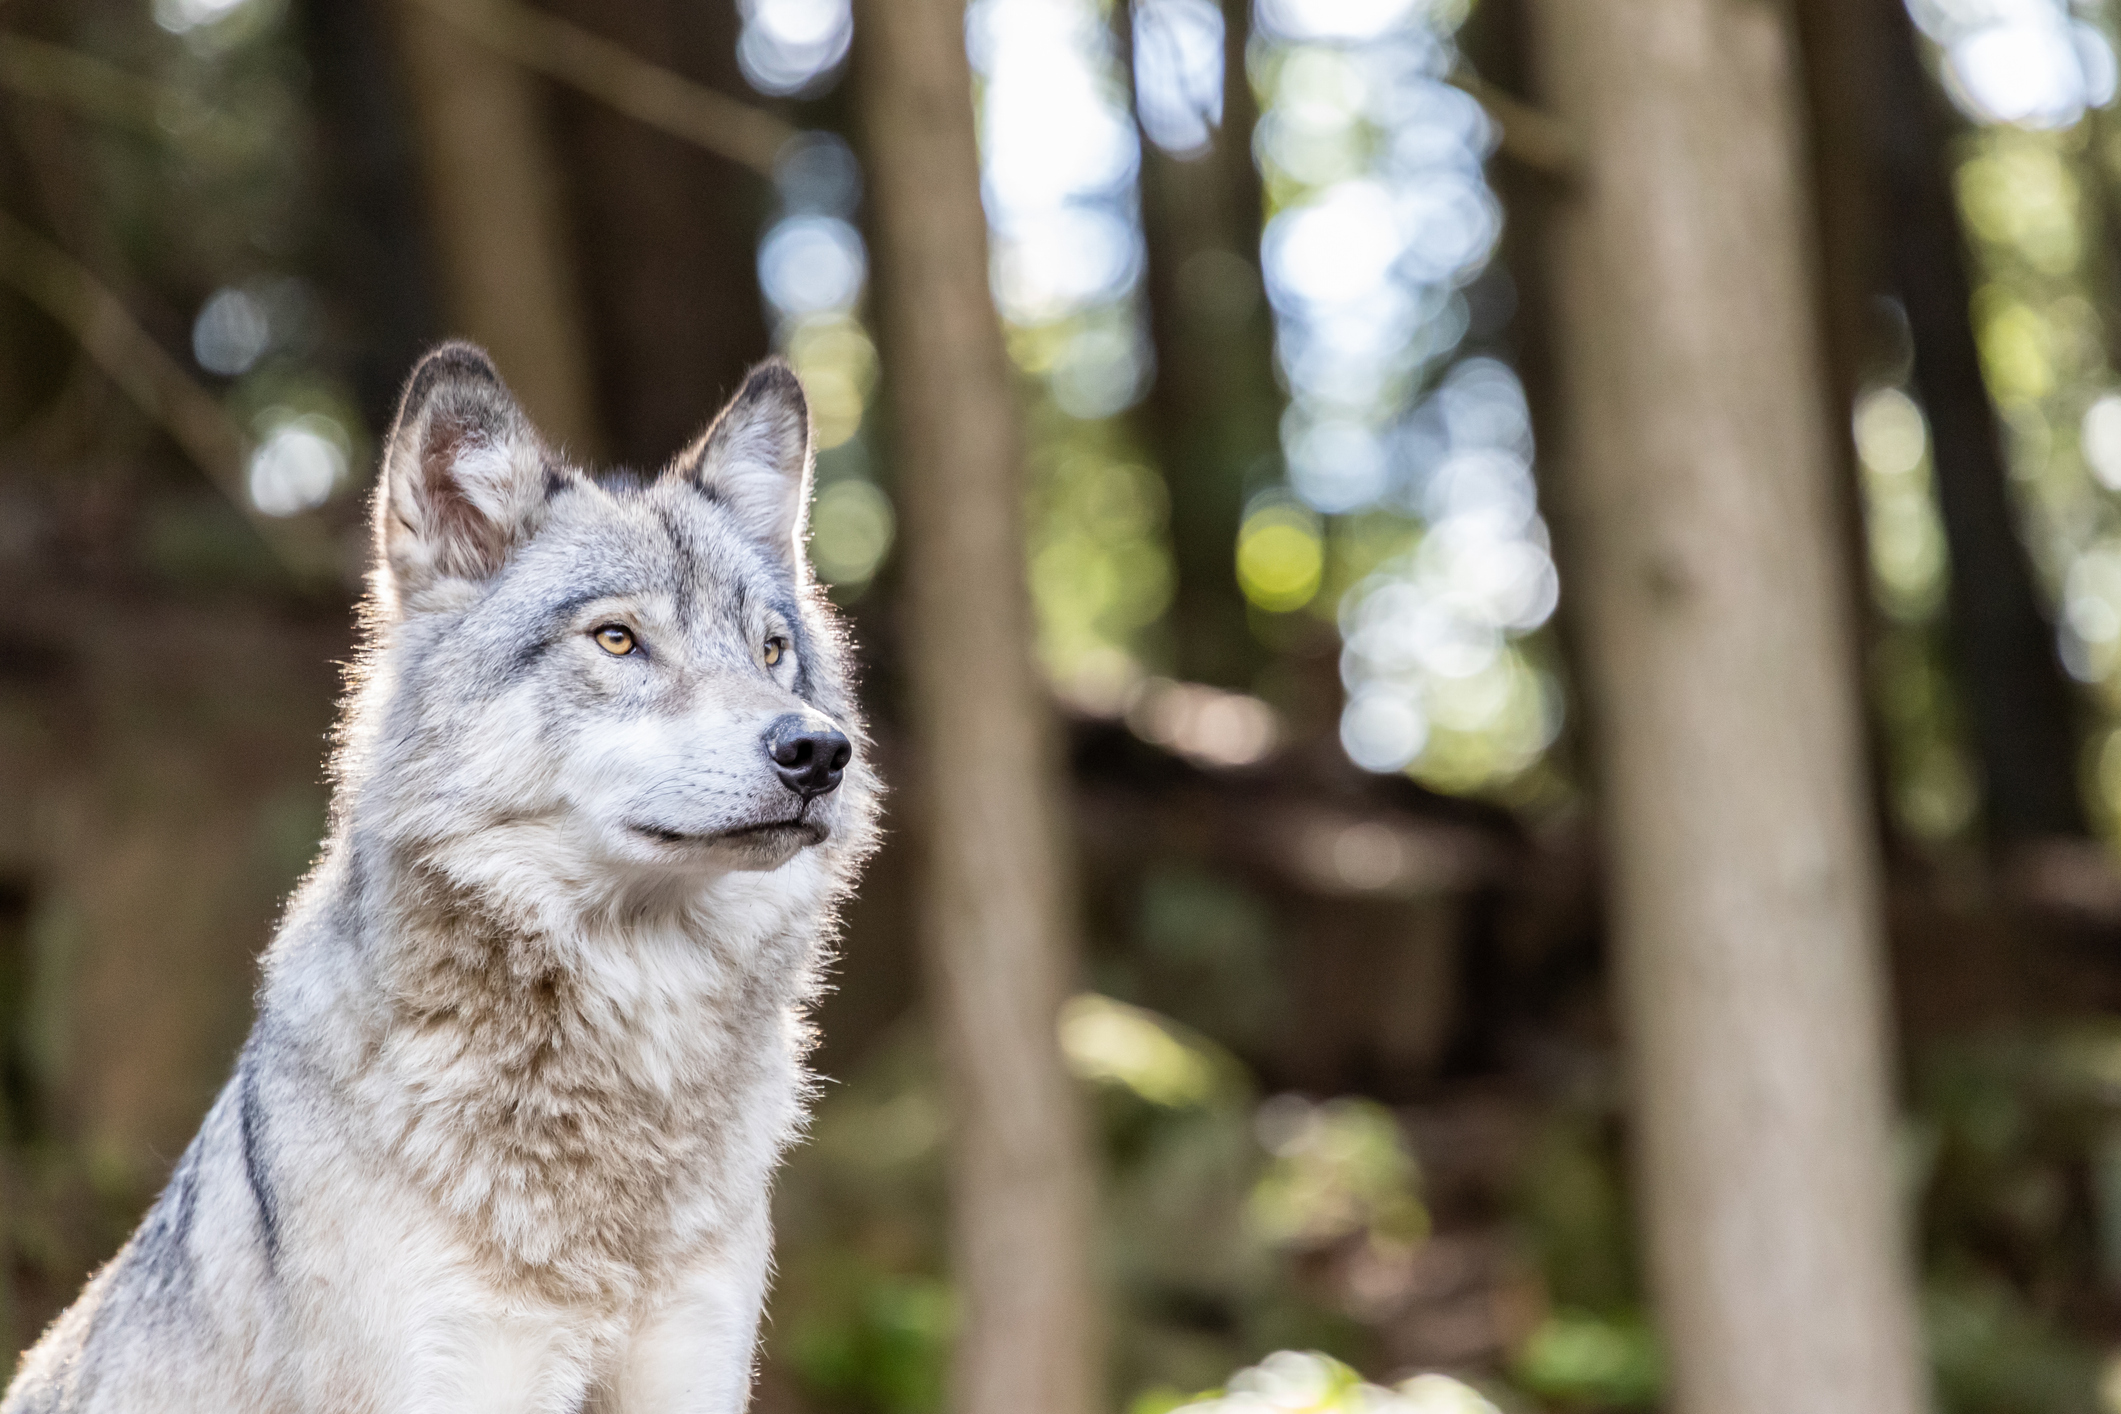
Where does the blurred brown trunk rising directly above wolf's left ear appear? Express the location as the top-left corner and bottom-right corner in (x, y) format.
(392, 0), (602, 456)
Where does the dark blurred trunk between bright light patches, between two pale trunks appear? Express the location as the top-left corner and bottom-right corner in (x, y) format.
(1114, 0), (1281, 689)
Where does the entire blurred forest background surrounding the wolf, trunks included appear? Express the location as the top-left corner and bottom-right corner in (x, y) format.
(0, 0), (2121, 1414)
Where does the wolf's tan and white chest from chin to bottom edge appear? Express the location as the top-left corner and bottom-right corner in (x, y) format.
(258, 861), (825, 1414)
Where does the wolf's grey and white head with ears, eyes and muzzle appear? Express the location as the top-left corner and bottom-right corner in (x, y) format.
(339, 343), (876, 924)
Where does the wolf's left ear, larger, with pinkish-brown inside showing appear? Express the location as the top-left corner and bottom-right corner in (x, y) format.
(375, 343), (545, 591)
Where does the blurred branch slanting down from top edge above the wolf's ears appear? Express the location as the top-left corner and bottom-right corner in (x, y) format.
(416, 0), (797, 176)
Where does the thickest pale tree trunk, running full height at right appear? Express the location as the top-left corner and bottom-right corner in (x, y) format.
(1529, 0), (1926, 1414)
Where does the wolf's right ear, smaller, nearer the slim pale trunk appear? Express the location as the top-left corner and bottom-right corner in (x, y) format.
(677, 358), (810, 570)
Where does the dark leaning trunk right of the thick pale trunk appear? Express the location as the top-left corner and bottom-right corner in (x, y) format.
(1796, 0), (2087, 846)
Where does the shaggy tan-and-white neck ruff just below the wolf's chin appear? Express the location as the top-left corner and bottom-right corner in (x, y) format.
(354, 873), (810, 1308)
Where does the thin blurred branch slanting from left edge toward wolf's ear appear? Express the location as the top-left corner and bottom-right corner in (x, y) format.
(0, 212), (333, 585)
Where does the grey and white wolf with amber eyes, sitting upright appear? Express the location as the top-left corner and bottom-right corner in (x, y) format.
(0, 343), (880, 1414)
